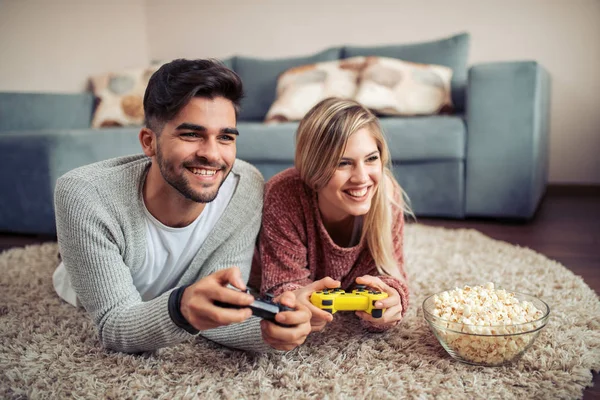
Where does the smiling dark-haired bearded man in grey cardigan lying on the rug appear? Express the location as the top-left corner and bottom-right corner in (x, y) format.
(54, 60), (311, 352)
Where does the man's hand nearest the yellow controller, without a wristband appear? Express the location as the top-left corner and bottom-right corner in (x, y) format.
(260, 292), (311, 351)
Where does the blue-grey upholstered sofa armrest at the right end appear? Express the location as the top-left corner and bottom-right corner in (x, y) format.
(465, 61), (550, 219)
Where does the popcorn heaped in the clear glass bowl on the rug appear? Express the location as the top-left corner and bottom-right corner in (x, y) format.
(428, 282), (546, 365)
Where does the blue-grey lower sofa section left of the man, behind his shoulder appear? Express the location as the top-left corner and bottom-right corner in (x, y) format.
(0, 127), (141, 235)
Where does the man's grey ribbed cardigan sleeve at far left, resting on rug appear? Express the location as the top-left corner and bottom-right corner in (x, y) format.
(55, 178), (190, 352)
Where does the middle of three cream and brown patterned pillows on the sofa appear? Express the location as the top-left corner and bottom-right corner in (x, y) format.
(265, 59), (359, 123)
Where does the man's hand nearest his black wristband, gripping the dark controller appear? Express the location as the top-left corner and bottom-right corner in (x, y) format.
(181, 267), (254, 331)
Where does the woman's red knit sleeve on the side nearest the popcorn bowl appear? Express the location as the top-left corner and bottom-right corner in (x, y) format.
(361, 211), (409, 332)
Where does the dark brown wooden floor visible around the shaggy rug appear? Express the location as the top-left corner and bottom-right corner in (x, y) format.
(0, 187), (600, 400)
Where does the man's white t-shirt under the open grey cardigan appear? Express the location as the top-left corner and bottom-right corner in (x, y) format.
(52, 172), (239, 306)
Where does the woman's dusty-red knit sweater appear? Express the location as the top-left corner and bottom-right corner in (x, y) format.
(250, 168), (408, 326)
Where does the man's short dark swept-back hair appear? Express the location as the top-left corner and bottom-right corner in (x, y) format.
(144, 59), (244, 135)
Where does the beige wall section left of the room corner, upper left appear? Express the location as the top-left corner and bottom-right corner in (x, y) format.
(0, 0), (148, 92)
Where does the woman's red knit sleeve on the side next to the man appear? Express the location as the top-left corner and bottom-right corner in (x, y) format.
(258, 177), (312, 295)
